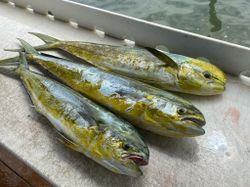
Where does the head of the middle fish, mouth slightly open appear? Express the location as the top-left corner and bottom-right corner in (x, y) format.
(145, 94), (206, 138)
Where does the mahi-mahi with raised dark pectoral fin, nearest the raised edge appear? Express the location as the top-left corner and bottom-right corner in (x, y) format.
(7, 33), (226, 95)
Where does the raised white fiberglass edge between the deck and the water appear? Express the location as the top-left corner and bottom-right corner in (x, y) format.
(0, 0), (250, 75)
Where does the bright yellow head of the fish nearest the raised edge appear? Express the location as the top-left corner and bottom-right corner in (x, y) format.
(178, 58), (226, 95)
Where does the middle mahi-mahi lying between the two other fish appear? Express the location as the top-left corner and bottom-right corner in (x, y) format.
(1, 40), (205, 137)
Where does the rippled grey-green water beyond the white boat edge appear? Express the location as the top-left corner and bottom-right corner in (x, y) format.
(72, 0), (250, 47)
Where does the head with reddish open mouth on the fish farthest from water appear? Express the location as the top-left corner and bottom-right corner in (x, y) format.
(102, 127), (149, 177)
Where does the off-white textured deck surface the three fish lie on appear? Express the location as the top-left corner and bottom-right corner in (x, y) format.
(0, 3), (250, 186)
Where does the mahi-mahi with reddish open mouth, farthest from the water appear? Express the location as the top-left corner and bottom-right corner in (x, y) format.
(0, 54), (149, 177)
